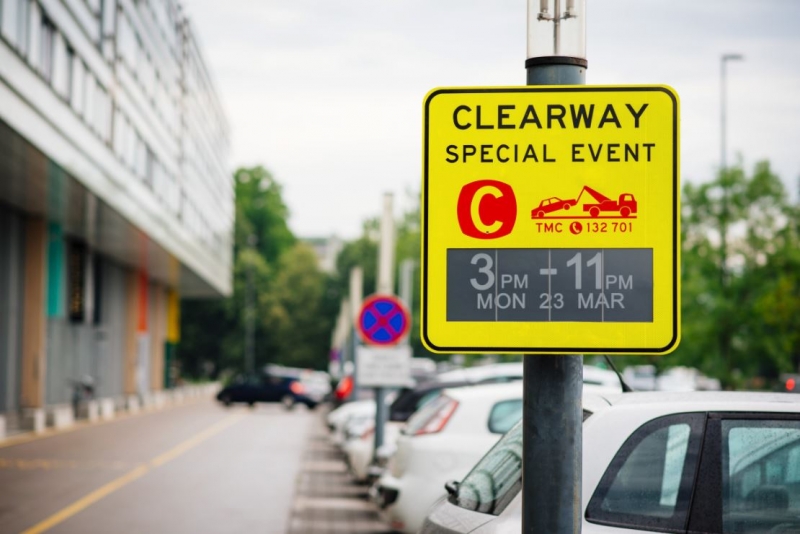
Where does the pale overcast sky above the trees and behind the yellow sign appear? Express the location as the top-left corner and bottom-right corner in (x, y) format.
(183, 0), (800, 238)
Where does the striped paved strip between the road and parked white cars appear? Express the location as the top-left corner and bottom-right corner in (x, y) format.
(287, 410), (392, 534)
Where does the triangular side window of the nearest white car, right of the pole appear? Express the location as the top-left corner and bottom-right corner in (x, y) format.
(586, 414), (704, 532)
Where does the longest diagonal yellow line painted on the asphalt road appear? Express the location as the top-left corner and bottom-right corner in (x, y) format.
(21, 414), (244, 534)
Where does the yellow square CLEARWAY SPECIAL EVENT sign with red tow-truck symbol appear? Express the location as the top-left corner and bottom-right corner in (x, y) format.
(421, 86), (680, 354)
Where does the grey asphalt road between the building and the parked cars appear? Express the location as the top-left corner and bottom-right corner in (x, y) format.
(0, 401), (313, 534)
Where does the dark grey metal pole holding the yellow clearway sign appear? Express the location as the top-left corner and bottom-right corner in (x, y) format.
(522, 0), (587, 534)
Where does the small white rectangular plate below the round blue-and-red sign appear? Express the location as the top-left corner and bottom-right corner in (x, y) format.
(356, 345), (411, 387)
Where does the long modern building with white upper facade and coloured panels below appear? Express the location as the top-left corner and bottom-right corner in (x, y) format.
(0, 0), (234, 432)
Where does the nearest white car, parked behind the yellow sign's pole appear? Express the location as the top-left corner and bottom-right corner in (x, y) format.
(420, 392), (800, 534)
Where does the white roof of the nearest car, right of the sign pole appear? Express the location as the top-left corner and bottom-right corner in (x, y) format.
(604, 391), (800, 413)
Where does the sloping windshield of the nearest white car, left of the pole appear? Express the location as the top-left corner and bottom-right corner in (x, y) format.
(451, 410), (591, 515)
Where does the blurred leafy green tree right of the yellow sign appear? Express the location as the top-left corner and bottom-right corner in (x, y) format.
(664, 162), (798, 385)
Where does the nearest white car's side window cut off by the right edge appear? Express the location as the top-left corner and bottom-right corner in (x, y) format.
(721, 419), (800, 534)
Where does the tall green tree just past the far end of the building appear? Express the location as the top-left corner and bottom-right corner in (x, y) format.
(179, 166), (335, 376)
